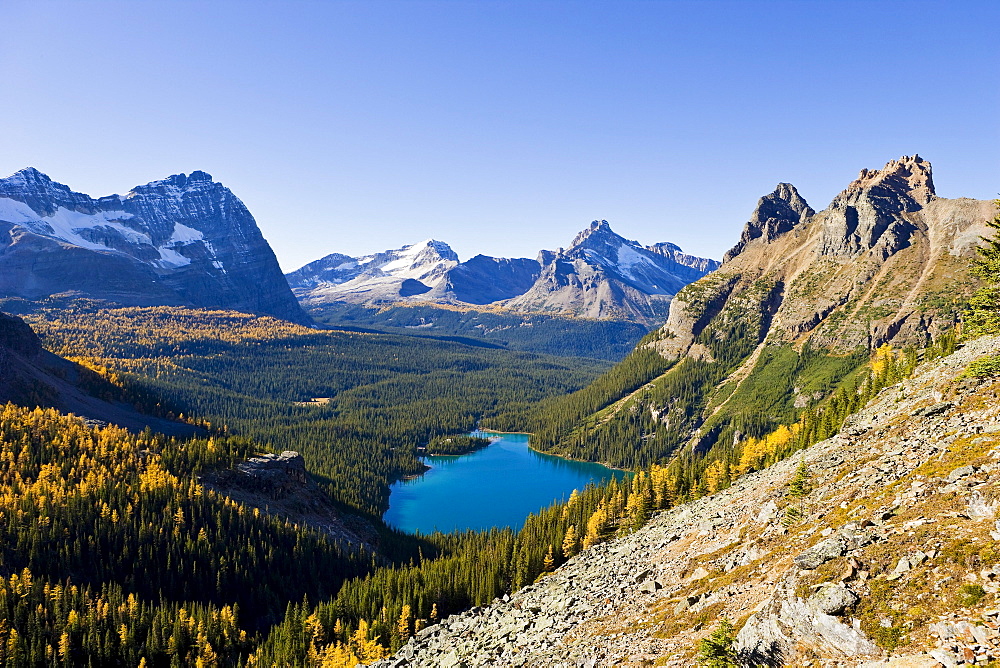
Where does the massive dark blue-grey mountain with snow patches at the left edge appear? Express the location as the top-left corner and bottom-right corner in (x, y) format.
(0, 168), (308, 321)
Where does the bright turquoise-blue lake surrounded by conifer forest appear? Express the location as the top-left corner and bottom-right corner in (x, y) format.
(385, 432), (628, 533)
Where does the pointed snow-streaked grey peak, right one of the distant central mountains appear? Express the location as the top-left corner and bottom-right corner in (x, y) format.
(505, 220), (719, 324)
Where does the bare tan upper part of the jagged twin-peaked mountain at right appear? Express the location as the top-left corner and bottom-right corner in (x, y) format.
(657, 156), (995, 357)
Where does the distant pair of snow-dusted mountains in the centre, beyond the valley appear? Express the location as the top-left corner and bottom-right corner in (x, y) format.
(287, 221), (719, 324)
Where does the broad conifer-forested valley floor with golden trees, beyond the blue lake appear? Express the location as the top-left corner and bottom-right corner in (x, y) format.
(17, 302), (606, 515)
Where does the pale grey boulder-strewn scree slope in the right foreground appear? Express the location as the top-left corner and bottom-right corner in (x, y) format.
(375, 338), (1000, 668)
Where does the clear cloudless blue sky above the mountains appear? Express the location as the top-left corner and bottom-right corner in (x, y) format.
(0, 0), (1000, 270)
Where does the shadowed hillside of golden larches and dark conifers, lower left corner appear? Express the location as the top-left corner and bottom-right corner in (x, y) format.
(0, 404), (370, 666)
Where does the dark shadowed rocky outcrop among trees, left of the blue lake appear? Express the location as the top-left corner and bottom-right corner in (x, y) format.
(202, 450), (378, 551)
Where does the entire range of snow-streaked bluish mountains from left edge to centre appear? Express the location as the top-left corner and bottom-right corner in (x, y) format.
(0, 168), (718, 326)
